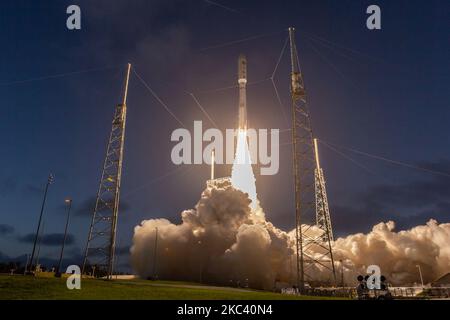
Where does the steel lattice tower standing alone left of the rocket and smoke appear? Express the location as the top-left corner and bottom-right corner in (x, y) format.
(82, 64), (131, 279)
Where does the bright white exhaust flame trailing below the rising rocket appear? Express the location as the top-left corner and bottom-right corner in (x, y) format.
(231, 129), (262, 214)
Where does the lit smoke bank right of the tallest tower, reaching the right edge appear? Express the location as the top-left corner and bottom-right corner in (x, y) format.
(334, 220), (450, 285)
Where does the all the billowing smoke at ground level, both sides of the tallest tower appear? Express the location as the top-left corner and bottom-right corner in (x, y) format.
(131, 182), (450, 290)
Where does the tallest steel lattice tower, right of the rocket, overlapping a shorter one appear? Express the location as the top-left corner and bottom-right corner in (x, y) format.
(289, 28), (336, 292)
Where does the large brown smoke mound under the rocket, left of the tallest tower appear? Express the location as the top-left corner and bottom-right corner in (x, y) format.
(131, 181), (293, 289)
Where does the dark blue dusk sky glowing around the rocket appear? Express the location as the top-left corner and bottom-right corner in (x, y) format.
(0, 0), (450, 270)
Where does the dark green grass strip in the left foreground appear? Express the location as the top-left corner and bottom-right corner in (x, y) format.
(0, 275), (344, 300)
